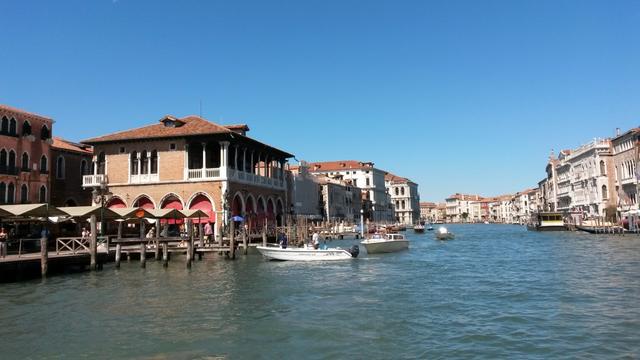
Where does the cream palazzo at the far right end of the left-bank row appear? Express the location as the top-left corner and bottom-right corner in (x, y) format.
(384, 173), (420, 225)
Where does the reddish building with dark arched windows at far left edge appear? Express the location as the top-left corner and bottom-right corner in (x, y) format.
(0, 105), (53, 204)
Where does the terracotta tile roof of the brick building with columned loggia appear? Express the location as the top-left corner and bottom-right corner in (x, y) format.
(82, 115), (231, 144)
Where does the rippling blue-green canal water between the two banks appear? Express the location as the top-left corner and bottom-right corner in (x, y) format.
(0, 225), (640, 359)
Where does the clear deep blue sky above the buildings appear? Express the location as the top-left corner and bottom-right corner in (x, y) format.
(0, 0), (640, 201)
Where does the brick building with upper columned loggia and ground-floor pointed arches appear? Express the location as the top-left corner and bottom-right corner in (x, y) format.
(83, 116), (293, 236)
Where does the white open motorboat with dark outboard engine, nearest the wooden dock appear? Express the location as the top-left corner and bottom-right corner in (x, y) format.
(256, 245), (360, 261)
